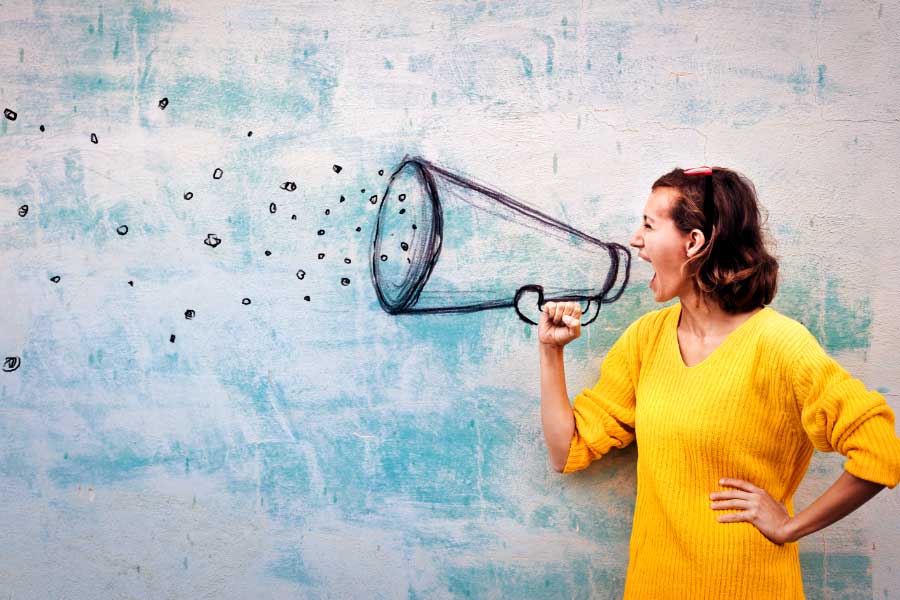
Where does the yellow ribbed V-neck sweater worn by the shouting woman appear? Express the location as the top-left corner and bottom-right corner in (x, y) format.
(563, 304), (900, 600)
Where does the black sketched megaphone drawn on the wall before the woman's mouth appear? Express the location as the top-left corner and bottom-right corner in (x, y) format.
(371, 157), (631, 325)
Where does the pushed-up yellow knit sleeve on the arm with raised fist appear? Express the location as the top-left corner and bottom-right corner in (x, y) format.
(562, 319), (640, 473)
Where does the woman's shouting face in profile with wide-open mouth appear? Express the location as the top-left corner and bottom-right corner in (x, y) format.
(630, 187), (702, 302)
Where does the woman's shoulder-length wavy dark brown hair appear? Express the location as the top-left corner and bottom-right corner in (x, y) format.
(652, 167), (778, 314)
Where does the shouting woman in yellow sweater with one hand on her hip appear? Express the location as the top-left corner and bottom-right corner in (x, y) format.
(539, 167), (900, 600)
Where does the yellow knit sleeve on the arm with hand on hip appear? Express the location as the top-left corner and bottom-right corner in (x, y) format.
(793, 331), (900, 488)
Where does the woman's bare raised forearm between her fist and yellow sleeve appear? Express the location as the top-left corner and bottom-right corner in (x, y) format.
(539, 344), (575, 473)
